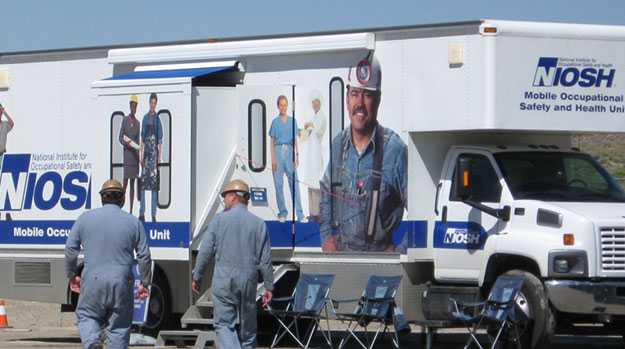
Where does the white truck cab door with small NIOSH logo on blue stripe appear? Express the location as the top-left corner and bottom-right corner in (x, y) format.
(433, 150), (502, 282)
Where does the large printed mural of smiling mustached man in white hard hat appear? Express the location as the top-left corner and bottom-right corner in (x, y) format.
(320, 55), (408, 252)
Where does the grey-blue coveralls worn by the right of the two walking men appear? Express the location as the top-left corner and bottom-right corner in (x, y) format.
(193, 204), (273, 349)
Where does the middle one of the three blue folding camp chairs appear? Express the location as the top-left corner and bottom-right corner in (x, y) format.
(332, 276), (409, 349)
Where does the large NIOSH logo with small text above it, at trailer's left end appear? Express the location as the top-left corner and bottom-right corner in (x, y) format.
(0, 153), (91, 211)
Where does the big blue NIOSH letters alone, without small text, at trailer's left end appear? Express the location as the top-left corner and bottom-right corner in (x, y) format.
(0, 154), (91, 211)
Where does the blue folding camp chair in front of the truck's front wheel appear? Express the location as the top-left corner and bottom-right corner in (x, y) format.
(449, 275), (528, 349)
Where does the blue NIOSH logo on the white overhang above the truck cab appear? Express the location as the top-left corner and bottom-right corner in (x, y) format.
(534, 57), (616, 87)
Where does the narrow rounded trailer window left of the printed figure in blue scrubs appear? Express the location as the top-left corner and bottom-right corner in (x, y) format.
(247, 99), (267, 172)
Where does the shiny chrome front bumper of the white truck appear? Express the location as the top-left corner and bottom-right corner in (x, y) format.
(545, 280), (625, 315)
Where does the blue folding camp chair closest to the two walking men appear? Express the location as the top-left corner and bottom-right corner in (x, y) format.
(267, 274), (334, 349)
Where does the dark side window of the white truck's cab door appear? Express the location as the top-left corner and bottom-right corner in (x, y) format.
(450, 153), (501, 202)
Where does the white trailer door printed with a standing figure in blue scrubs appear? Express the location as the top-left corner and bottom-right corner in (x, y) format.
(235, 85), (306, 250)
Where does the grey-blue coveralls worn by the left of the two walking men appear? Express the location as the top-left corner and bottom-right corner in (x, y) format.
(65, 204), (152, 348)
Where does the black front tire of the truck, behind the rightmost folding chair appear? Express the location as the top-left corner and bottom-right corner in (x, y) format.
(504, 270), (556, 349)
